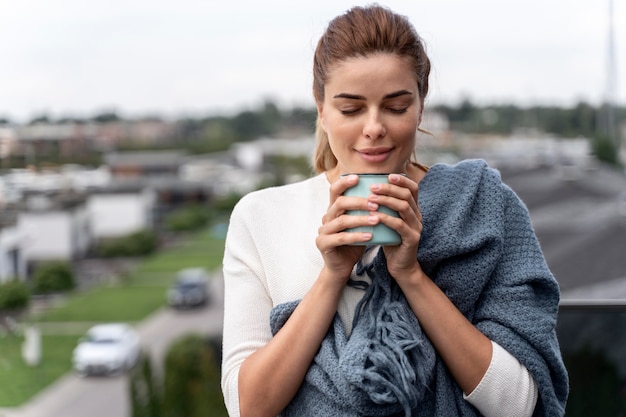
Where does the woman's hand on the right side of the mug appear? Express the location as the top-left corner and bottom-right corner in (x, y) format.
(368, 174), (422, 281)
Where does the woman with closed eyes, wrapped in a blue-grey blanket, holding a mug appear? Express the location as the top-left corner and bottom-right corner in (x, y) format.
(222, 6), (568, 416)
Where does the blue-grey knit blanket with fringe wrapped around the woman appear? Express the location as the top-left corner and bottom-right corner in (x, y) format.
(270, 160), (568, 417)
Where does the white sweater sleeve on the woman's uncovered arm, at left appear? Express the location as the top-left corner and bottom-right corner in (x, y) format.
(221, 197), (272, 417)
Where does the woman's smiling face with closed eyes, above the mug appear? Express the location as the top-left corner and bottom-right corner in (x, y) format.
(318, 53), (422, 178)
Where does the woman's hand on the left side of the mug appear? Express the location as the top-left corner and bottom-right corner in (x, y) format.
(315, 175), (372, 284)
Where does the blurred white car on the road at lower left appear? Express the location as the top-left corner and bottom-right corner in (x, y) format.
(72, 323), (141, 376)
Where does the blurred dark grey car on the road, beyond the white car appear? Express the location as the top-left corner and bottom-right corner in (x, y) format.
(167, 268), (209, 308)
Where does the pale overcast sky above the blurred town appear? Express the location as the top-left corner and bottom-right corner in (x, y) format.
(0, 0), (626, 121)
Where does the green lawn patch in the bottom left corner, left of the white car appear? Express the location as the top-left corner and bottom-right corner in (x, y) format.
(0, 335), (78, 407)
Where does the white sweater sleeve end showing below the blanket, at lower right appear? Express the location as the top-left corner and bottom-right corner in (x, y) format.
(463, 342), (538, 417)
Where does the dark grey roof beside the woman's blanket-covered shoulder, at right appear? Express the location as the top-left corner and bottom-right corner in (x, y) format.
(501, 165), (626, 292)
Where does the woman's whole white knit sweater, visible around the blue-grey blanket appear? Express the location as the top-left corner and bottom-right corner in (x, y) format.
(222, 174), (537, 417)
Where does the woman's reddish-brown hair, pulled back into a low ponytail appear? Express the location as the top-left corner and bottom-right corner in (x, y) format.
(313, 5), (430, 173)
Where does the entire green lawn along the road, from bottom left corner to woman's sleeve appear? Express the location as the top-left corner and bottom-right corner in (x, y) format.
(0, 231), (224, 407)
